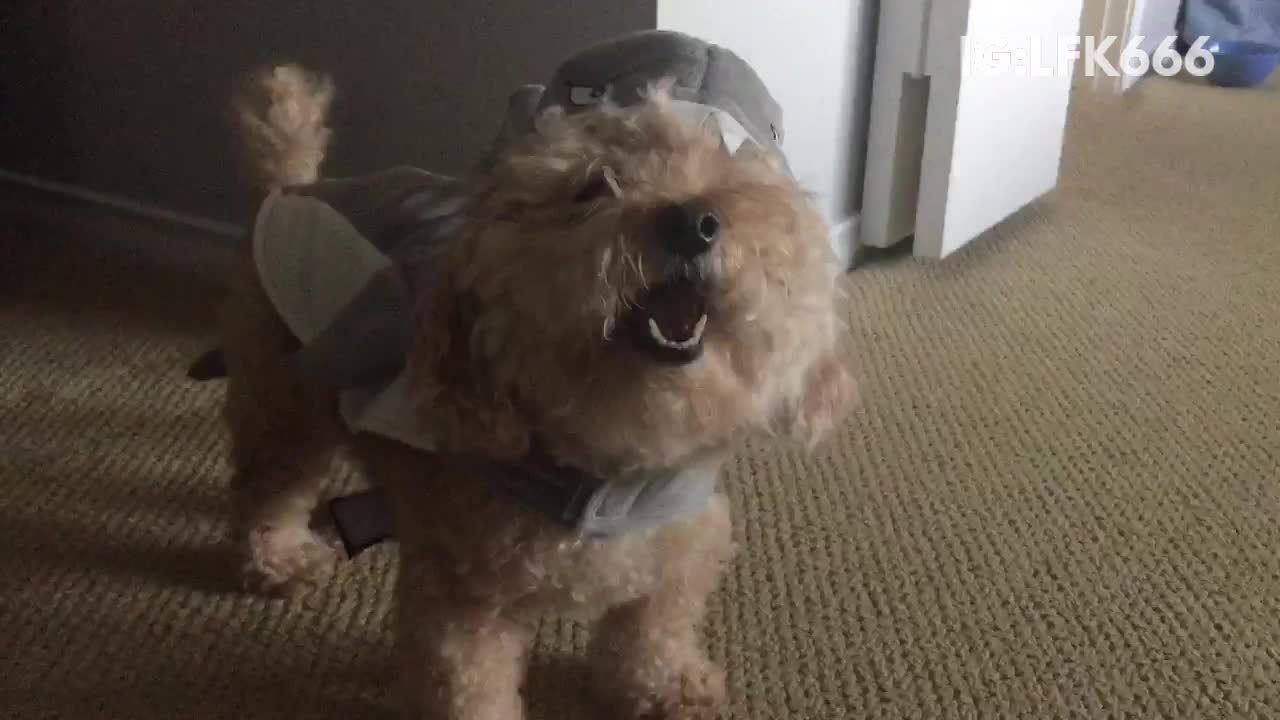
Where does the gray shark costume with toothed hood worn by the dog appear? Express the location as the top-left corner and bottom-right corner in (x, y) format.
(209, 31), (782, 556)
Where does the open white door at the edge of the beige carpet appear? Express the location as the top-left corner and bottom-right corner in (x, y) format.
(860, 0), (1082, 258)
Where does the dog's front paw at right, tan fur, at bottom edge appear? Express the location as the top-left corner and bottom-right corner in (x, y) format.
(611, 660), (726, 720)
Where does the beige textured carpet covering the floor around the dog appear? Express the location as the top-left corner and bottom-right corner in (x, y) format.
(0, 75), (1280, 720)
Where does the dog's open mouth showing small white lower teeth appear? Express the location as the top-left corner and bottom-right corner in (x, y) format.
(626, 277), (707, 365)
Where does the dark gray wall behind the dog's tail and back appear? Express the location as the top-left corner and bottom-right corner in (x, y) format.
(0, 0), (657, 220)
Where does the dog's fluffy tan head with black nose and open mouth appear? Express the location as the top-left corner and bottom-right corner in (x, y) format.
(413, 95), (850, 470)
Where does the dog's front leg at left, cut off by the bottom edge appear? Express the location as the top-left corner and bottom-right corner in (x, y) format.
(398, 597), (531, 720)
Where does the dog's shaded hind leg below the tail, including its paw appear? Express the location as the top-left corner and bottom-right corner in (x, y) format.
(223, 266), (344, 594)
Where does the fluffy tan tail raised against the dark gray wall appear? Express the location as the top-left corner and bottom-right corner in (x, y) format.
(233, 65), (333, 190)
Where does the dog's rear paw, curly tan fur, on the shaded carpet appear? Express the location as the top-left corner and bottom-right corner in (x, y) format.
(241, 525), (338, 596)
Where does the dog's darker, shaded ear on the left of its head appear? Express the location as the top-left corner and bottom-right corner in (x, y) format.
(411, 274), (530, 459)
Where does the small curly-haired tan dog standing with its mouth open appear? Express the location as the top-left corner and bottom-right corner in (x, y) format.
(212, 37), (850, 720)
